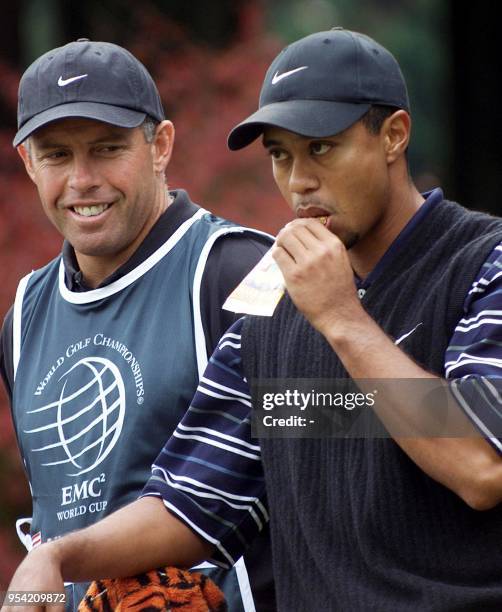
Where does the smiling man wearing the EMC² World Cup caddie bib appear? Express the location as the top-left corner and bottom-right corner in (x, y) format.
(0, 39), (271, 610)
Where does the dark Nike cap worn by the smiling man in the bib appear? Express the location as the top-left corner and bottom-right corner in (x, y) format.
(13, 38), (164, 147)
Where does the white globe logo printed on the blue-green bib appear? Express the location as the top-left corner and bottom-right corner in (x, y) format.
(25, 357), (125, 476)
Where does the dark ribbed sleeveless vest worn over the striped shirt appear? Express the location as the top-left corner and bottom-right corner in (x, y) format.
(242, 201), (502, 612)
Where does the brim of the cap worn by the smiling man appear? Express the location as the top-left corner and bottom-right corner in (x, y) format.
(13, 102), (146, 147)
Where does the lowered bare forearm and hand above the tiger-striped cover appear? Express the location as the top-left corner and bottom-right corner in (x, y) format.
(2, 497), (213, 612)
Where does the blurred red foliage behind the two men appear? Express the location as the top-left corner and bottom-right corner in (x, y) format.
(0, 3), (290, 590)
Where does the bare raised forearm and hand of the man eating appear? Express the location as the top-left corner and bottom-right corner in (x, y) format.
(273, 219), (502, 510)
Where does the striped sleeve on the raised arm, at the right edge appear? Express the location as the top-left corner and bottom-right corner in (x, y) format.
(445, 244), (502, 454)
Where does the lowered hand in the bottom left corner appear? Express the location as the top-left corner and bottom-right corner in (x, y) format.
(1, 543), (64, 612)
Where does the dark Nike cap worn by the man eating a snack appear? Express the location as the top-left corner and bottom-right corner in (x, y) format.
(228, 28), (410, 151)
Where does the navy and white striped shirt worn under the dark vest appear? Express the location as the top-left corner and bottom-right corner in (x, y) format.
(143, 190), (502, 567)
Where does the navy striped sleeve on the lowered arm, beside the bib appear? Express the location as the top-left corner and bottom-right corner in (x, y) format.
(142, 319), (268, 567)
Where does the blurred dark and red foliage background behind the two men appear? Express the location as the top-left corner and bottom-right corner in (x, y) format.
(0, 0), (502, 590)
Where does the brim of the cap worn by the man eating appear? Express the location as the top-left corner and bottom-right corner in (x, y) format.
(228, 100), (371, 151)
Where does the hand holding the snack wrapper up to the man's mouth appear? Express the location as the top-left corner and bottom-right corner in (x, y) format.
(273, 219), (364, 335)
